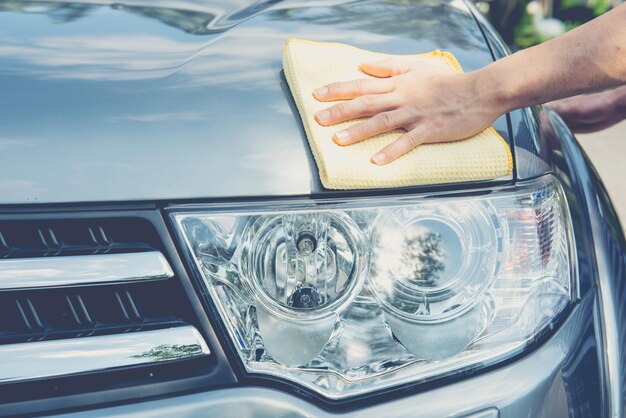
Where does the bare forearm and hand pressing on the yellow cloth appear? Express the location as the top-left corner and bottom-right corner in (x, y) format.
(314, 4), (626, 164)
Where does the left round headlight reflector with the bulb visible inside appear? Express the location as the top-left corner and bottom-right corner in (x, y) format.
(239, 213), (367, 319)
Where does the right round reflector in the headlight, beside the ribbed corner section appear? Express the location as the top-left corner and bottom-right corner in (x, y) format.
(369, 202), (505, 323)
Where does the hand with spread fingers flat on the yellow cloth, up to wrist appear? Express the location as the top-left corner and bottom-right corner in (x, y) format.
(313, 58), (506, 165)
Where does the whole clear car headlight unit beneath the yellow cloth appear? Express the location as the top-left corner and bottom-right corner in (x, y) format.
(171, 176), (575, 399)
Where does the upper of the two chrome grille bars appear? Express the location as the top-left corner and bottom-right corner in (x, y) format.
(0, 251), (174, 291)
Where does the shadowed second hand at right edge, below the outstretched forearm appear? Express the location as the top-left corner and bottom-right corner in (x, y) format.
(547, 86), (626, 133)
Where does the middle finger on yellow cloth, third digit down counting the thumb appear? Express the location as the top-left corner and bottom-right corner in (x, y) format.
(315, 94), (394, 126)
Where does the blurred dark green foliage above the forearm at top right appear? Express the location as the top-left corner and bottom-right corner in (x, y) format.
(474, 0), (621, 50)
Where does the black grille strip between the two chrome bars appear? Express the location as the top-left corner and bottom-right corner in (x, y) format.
(0, 282), (193, 344)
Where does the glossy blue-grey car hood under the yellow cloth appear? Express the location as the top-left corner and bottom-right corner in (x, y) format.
(0, 0), (507, 204)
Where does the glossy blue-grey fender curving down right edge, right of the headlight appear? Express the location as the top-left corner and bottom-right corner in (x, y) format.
(535, 108), (626, 417)
